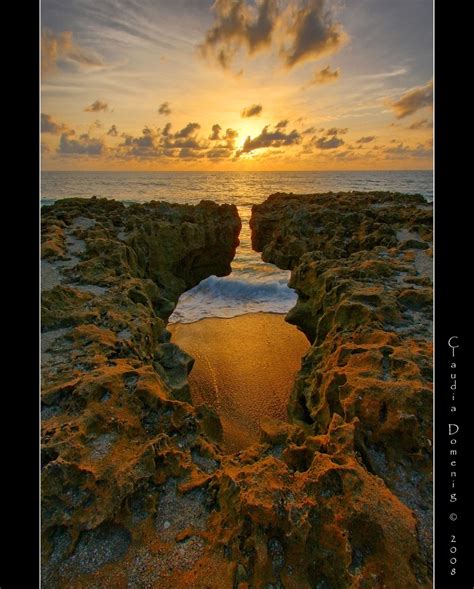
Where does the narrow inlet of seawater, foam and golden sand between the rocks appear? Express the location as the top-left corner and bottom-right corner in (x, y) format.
(168, 207), (310, 453)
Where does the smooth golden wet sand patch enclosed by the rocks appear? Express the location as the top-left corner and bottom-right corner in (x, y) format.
(168, 313), (309, 452)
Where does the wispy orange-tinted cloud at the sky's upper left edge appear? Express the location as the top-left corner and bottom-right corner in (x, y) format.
(41, 29), (105, 76)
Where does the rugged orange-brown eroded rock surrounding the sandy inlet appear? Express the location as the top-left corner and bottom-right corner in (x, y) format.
(42, 193), (432, 589)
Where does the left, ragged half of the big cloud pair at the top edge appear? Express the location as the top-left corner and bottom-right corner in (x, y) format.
(200, 0), (278, 68)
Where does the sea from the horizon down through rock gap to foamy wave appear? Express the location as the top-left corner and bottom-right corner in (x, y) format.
(41, 171), (433, 323)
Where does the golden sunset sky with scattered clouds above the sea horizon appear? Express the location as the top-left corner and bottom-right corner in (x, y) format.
(41, 0), (433, 171)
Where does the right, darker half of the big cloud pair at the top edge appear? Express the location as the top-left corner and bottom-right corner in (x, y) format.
(282, 0), (348, 67)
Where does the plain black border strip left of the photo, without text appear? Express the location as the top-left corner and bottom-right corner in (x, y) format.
(4, 2), (40, 589)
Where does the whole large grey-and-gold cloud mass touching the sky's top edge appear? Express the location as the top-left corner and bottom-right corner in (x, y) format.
(199, 0), (348, 69)
